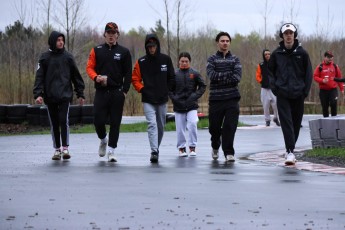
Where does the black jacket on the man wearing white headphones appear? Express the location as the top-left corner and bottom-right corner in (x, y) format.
(268, 39), (313, 99)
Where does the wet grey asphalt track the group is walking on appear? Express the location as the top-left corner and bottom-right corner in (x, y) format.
(0, 116), (345, 230)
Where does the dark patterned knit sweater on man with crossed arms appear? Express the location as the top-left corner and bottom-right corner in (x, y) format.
(206, 51), (242, 101)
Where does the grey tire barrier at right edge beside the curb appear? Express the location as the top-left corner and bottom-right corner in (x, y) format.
(309, 117), (345, 148)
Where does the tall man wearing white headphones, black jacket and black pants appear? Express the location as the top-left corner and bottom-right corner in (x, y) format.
(268, 23), (313, 165)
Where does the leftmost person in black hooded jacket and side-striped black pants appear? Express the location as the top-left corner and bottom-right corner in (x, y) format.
(33, 31), (85, 160)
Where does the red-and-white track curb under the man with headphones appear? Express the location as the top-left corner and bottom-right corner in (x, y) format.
(248, 149), (345, 175)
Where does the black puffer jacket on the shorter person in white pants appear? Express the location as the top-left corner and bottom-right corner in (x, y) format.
(169, 68), (206, 112)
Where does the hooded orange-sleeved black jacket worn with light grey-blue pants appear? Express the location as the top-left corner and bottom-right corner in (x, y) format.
(132, 34), (175, 104)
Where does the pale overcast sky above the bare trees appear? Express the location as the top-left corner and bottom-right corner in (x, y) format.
(0, 0), (345, 38)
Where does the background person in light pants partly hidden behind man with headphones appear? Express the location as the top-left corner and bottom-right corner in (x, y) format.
(256, 49), (280, 126)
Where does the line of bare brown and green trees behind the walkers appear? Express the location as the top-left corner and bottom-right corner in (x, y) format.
(0, 18), (345, 115)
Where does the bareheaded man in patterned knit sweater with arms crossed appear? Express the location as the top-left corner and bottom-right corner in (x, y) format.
(206, 32), (242, 162)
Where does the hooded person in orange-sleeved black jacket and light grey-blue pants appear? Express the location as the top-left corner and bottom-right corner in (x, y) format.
(132, 34), (175, 163)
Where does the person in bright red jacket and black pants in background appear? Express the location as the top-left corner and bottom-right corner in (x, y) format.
(314, 51), (344, 117)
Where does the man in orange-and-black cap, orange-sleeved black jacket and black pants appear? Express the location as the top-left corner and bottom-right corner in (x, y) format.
(86, 22), (132, 162)
